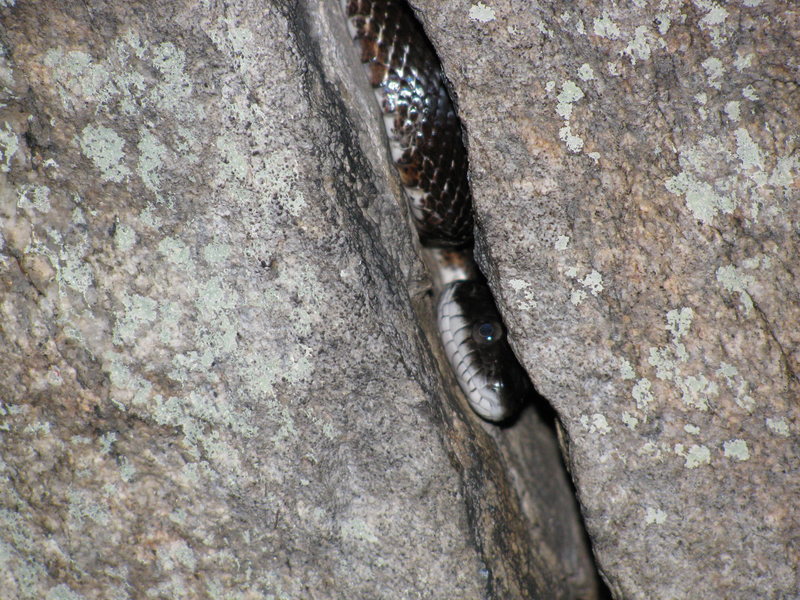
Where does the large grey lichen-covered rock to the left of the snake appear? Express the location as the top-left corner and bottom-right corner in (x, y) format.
(0, 0), (600, 600)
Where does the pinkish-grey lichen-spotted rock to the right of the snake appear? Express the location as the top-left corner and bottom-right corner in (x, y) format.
(413, 0), (800, 600)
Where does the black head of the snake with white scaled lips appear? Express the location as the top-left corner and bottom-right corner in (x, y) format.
(437, 281), (533, 422)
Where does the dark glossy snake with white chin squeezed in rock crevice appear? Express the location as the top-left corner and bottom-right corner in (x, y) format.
(342, 0), (533, 422)
